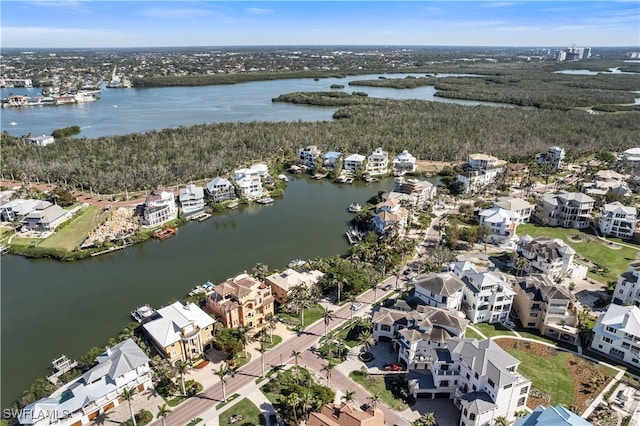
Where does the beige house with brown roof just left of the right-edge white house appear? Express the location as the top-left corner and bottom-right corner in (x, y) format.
(513, 275), (578, 345)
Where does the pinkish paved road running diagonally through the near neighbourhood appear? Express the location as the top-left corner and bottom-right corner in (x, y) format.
(153, 277), (398, 426)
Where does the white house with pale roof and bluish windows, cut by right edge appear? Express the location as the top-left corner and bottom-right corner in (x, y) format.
(591, 304), (640, 367)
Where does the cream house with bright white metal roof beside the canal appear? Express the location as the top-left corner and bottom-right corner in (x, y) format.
(142, 302), (215, 364)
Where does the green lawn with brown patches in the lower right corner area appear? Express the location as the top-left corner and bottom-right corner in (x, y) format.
(500, 342), (575, 407)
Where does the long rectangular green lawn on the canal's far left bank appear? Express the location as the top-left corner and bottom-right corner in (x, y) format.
(39, 206), (108, 251)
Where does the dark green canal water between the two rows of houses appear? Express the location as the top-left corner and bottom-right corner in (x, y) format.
(0, 178), (412, 407)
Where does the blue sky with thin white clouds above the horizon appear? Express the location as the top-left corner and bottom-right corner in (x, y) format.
(0, 0), (640, 48)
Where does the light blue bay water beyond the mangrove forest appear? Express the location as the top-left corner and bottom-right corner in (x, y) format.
(0, 74), (502, 138)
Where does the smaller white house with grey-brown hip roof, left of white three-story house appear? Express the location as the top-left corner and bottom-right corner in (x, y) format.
(415, 272), (464, 310)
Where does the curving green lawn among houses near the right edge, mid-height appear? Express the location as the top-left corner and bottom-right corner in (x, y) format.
(518, 223), (640, 282)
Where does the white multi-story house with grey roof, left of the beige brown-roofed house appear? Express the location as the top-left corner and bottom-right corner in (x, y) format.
(460, 269), (516, 324)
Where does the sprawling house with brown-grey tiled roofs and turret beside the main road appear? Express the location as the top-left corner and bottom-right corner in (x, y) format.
(371, 305), (469, 369)
